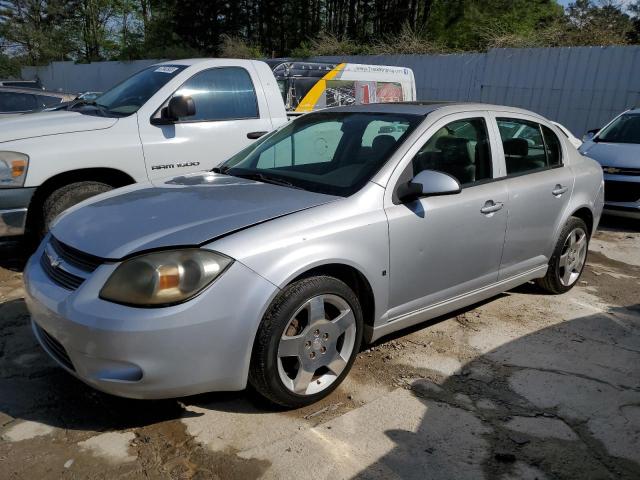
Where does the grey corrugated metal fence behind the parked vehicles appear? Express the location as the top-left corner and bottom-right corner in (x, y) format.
(22, 46), (640, 136)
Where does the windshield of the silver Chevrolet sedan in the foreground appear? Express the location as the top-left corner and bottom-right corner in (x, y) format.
(217, 112), (424, 196)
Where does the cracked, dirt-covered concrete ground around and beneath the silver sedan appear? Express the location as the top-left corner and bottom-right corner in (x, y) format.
(0, 220), (640, 479)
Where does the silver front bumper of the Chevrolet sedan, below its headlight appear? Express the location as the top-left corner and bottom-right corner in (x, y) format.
(24, 242), (278, 398)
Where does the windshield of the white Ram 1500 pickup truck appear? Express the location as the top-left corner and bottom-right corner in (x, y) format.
(78, 65), (187, 116)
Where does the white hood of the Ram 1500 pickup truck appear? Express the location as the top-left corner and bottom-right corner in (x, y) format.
(0, 111), (118, 143)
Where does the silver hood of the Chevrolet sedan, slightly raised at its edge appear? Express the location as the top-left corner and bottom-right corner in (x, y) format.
(51, 173), (339, 260)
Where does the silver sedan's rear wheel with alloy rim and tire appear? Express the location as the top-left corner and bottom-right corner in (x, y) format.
(537, 217), (589, 294)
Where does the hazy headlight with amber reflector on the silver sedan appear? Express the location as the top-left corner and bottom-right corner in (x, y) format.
(100, 248), (233, 307)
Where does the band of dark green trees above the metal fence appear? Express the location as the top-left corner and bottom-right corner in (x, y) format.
(0, 0), (640, 71)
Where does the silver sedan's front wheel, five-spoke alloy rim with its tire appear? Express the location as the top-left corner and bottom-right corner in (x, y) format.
(249, 276), (363, 408)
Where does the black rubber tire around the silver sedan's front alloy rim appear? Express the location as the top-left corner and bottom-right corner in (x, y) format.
(249, 276), (363, 408)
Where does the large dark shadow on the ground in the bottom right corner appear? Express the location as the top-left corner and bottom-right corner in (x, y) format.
(350, 304), (640, 480)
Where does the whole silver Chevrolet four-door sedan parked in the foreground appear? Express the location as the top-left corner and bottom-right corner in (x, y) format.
(24, 104), (603, 407)
